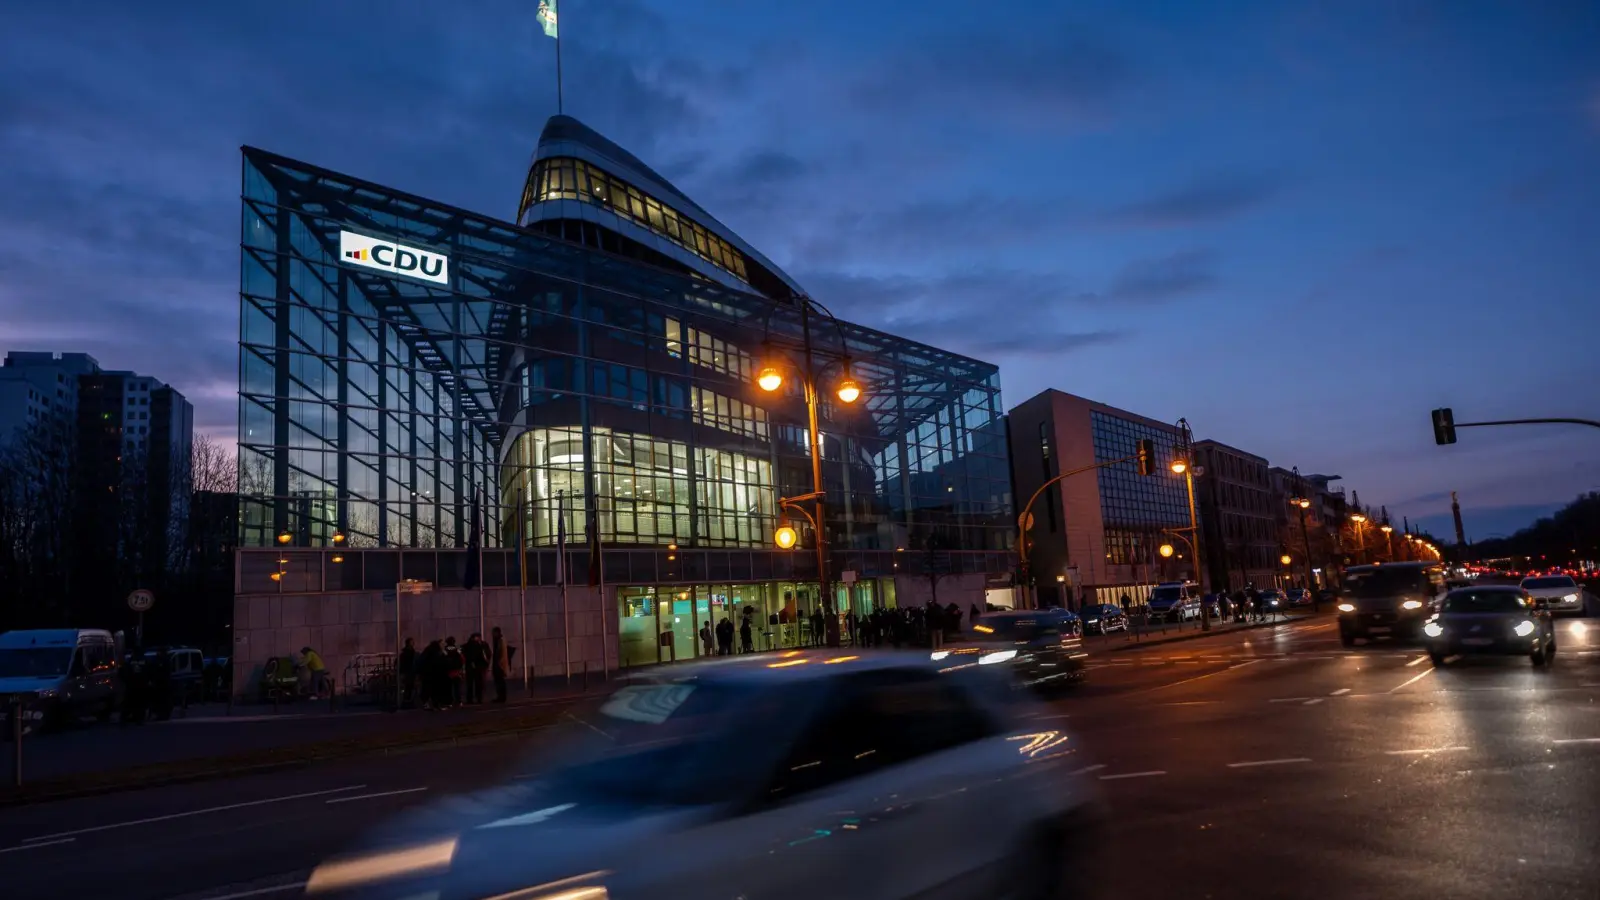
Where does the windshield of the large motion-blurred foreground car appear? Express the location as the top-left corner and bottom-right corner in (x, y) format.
(550, 681), (805, 807)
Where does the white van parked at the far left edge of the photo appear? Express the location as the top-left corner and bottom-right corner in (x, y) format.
(0, 628), (120, 738)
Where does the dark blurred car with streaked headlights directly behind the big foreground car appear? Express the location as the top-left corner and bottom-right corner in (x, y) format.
(933, 609), (1094, 689)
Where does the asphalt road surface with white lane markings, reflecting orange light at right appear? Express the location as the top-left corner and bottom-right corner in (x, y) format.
(0, 620), (1600, 900)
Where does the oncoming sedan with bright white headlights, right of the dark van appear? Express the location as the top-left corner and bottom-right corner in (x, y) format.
(1422, 585), (1555, 666)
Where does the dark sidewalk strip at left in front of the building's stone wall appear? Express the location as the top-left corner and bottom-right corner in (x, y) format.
(0, 679), (614, 804)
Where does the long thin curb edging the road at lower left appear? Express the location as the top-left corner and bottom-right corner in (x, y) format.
(0, 701), (578, 807)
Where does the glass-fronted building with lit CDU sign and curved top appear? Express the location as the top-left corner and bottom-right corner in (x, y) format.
(238, 117), (1013, 661)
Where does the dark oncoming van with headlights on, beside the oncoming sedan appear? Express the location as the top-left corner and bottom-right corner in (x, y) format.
(1338, 562), (1445, 647)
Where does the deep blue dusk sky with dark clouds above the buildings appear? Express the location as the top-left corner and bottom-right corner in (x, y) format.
(0, 0), (1600, 536)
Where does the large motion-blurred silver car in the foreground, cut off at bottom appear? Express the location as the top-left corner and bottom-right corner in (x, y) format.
(306, 650), (1099, 900)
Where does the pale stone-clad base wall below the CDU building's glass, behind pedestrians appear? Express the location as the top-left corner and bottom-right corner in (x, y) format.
(234, 585), (614, 703)
